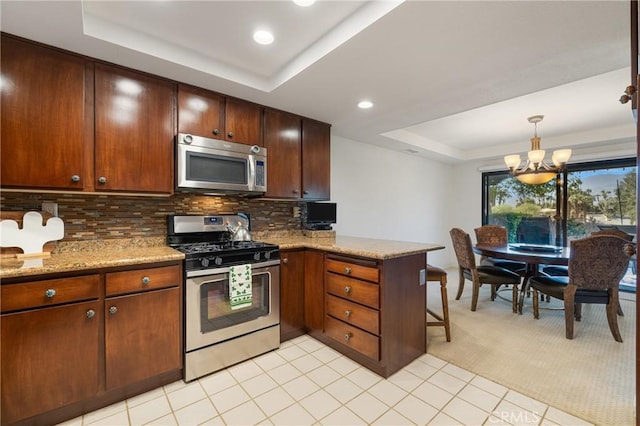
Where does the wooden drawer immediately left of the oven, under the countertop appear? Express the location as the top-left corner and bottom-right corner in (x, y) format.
(106, 265), (182, 296)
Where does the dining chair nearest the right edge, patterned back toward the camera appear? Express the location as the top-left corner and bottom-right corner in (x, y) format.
(529, 234), (635, 342)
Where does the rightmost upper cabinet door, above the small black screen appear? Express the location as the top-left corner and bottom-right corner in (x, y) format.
(302, 119), (331, 200)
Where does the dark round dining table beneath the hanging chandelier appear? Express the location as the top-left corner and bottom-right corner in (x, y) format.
(473, 243), (570, 315)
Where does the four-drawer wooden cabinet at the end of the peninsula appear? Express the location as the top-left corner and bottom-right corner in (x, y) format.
(319, 253), (426, 377)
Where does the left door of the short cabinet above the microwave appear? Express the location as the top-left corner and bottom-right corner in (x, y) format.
(178, 85), (225, 139)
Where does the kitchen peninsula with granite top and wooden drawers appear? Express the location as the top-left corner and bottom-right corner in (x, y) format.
(260, 231), (444, 377)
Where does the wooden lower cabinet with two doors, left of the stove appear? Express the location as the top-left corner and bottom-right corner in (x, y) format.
(0, 261), (183, 425)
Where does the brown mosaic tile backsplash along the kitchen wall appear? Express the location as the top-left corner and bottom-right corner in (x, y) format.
(0, 191), (305, 241)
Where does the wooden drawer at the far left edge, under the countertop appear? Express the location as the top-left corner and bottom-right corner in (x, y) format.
(0, 275), (100, 312)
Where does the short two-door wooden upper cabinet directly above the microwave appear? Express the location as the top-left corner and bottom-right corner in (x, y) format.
(178, 84), (263, 146)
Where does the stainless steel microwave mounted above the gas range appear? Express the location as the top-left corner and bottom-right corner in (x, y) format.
(176, 133), (267, 195)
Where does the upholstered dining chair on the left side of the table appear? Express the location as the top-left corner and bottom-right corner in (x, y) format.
(449, 228), (520, 313)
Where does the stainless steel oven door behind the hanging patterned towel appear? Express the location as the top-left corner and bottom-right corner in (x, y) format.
(185, 260), (280, 352)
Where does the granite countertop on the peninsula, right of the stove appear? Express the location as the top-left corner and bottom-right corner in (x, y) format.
(261, 235), (444, 260)
